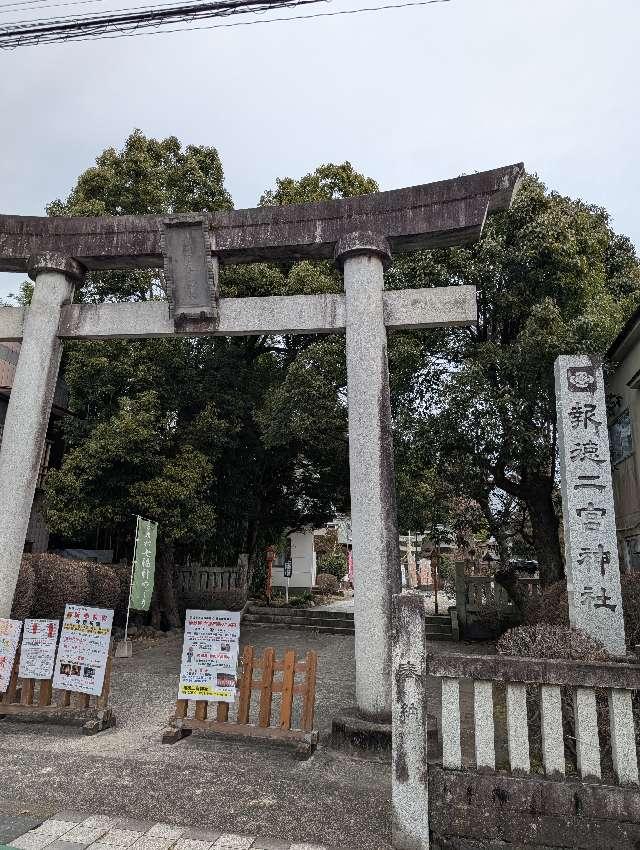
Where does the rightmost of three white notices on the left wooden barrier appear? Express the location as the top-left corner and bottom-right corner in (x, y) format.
(53, 605), (113, 696)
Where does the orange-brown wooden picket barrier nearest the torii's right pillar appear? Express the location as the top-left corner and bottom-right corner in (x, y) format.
(162, 646), (318, 753)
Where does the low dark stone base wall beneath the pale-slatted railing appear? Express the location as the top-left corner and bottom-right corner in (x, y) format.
(429, 765), (640, 850)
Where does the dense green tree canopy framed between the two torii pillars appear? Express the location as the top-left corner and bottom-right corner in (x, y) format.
(46, 131), (376, 625)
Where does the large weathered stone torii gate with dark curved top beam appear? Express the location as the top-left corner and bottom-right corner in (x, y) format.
(0, 164), (523, 721)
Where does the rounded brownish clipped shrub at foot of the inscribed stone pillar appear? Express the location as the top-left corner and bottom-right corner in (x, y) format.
(496, 623), (610, 661)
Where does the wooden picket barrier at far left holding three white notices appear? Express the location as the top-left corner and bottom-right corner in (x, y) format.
(0, 649), (116, 735)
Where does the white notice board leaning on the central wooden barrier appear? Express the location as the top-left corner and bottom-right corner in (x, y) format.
(178, 611), (240, 703)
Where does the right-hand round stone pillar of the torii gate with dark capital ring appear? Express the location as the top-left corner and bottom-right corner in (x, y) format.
(336, 233), (401, 722)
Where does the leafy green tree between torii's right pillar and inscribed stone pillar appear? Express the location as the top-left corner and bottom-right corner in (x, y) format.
(389, 172), (640, 583)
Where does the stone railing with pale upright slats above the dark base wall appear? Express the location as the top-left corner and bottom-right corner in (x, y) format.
(426, 654), (640, 785)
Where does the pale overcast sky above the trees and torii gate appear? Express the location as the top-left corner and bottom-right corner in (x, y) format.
(0, 0), (640, 297)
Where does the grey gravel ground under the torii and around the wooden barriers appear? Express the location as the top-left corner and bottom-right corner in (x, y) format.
(0, 626), (496, 850)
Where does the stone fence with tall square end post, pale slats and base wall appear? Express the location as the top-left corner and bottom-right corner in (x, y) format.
(392, 593), (640, 850)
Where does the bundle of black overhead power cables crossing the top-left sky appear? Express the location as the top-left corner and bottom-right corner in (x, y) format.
(0, 0), (452, 49)
